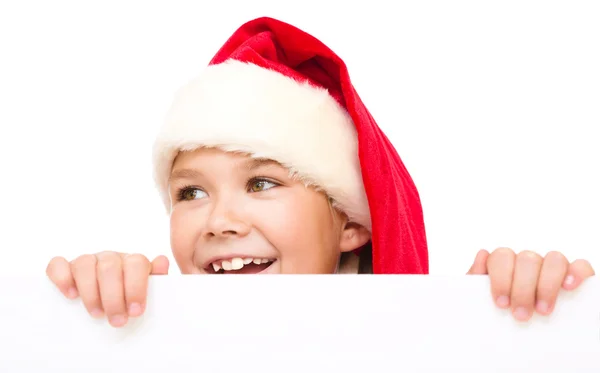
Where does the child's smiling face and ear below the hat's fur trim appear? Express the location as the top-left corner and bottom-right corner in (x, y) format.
(169, 149), (370, 274)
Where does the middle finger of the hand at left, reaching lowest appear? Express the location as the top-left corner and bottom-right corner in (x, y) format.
(96, 252), (127, 327)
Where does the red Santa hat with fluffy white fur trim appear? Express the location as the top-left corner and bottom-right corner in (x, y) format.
(153, 18), (429, 274)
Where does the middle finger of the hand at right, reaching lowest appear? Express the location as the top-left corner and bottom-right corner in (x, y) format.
(510, 251), (544, 321)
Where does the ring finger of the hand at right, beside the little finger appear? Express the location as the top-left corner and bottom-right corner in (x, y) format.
(535, 251), (569, 315)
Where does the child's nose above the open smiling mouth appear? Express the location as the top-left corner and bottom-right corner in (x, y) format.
(204, 195), (250, 238)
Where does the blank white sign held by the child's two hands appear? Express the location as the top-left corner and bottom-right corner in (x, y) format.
(0, 275), (600, 373)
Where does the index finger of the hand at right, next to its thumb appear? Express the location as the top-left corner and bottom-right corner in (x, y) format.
(487, 248), (516, 308)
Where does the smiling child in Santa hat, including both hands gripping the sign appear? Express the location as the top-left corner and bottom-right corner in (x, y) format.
(47, 18), (594, 327)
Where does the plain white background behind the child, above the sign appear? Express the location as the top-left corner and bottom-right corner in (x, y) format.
(0, 0), (600, 275)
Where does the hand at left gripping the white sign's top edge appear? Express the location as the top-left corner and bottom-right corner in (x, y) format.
(46, 251), (169, 327)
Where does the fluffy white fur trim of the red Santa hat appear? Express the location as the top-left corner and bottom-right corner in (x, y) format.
(153, 60), (371, 230)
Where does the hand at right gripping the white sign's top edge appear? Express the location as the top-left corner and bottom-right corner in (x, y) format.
(467, 248), (595, 321)
